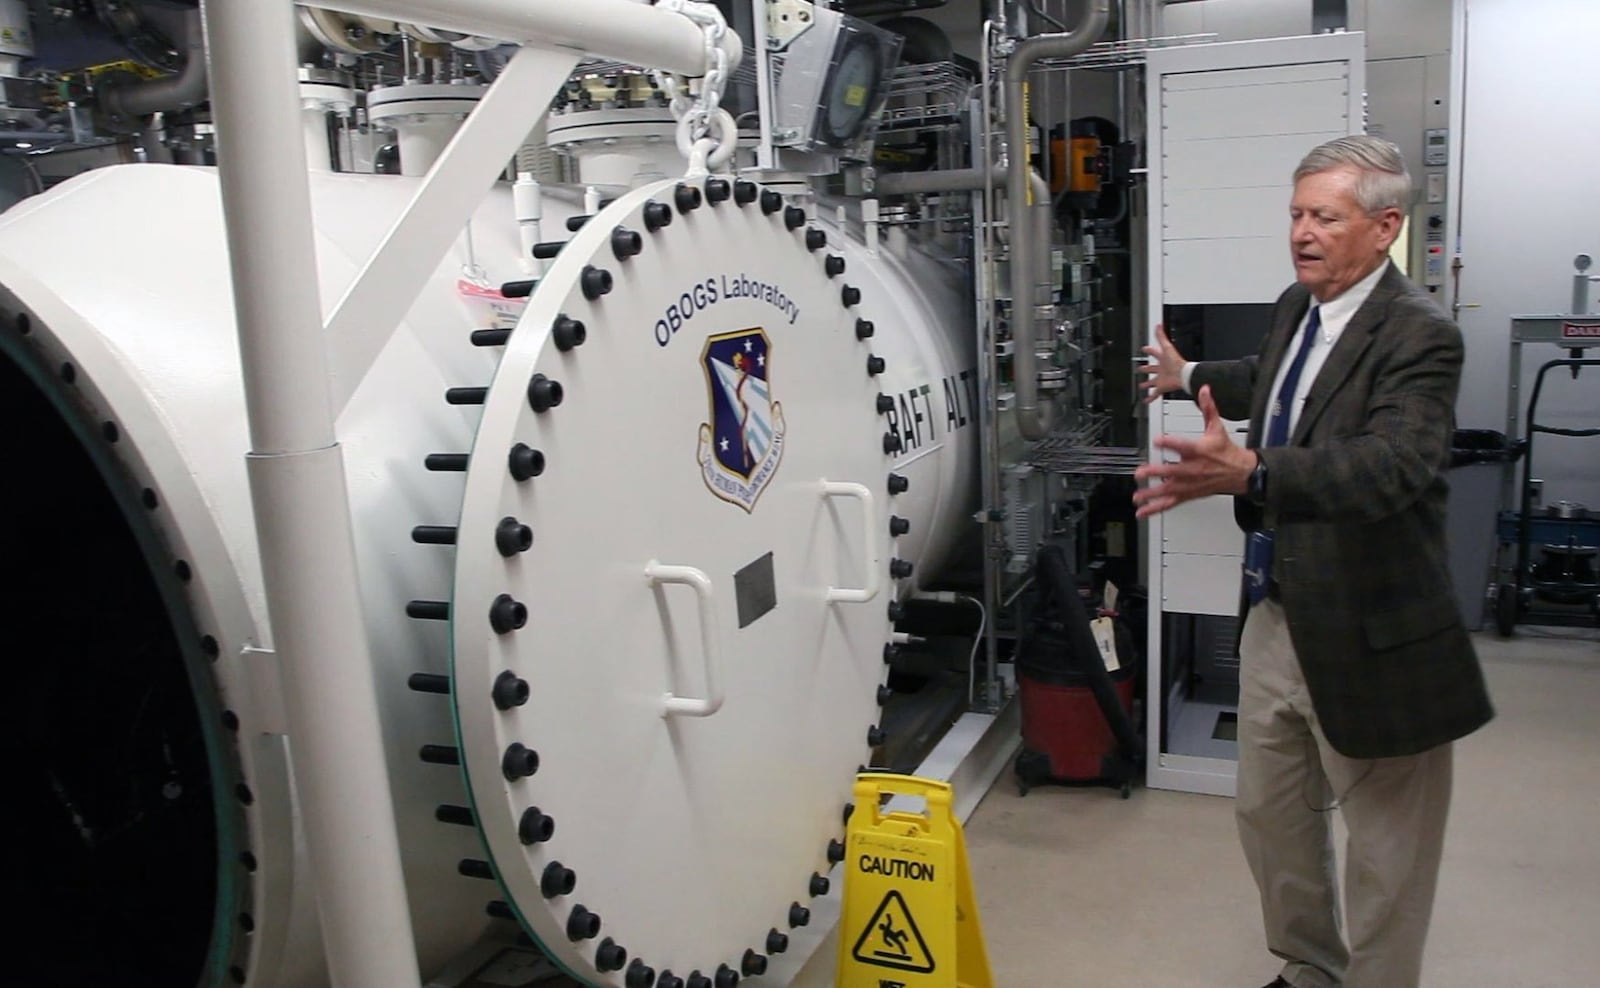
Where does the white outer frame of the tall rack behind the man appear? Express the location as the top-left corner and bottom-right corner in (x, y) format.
(1144, 32), (1366, 796)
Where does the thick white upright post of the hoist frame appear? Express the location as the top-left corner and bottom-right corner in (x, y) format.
(205, 0), (421, 988)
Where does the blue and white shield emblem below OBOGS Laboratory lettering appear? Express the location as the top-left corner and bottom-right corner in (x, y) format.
(694, 328), (784, 512)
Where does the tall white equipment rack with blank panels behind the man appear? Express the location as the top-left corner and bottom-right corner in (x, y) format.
(1146, 34), (1366, 795)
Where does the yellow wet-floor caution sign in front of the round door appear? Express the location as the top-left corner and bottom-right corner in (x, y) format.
(837, 772), (994, 988)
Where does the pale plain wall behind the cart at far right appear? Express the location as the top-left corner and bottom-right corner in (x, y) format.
(1445, 0), (1600, 508)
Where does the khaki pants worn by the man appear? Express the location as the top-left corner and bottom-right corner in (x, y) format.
(1235, 600), (1451, 988)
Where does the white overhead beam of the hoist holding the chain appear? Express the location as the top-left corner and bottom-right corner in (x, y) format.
(297, 0), (741, 75)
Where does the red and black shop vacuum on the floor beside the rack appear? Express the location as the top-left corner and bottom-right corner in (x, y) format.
(1014, 545), (1144, 799)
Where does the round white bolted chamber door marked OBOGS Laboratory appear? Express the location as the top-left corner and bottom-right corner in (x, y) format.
(451, 177), (906, 986)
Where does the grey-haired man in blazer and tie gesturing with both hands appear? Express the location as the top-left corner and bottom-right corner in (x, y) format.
(1134, 137), (1493, 988)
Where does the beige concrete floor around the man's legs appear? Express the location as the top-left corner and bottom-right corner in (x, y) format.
(966, 628), (1600, 988)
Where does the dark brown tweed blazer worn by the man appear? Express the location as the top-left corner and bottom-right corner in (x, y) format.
(1190, 264), (1494, 758)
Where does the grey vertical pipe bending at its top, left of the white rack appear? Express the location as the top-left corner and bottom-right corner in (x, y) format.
(1005, 0), (1110, 440)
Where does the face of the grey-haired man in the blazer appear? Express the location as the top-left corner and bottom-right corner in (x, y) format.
(1290, 165), (1400, 302)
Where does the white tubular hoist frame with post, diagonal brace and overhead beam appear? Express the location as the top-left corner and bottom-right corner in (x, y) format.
(205, 0), (720, 988)
